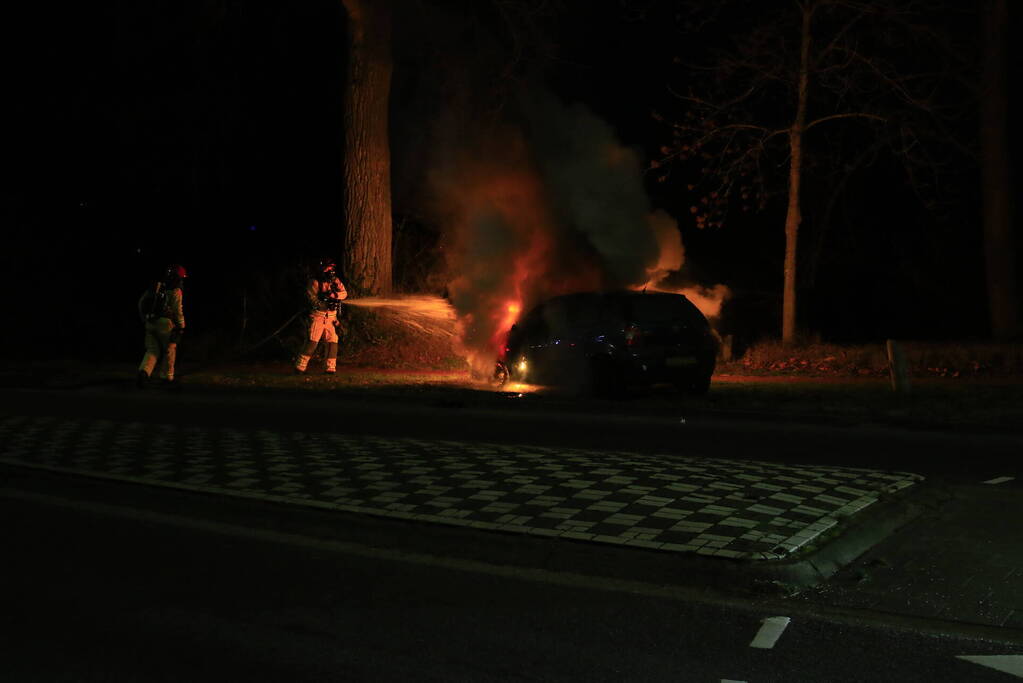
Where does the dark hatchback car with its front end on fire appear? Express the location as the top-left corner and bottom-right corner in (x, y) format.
(494, 291), (718, 396)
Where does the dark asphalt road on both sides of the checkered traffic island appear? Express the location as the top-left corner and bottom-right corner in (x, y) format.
(0, 388), (1023, 683)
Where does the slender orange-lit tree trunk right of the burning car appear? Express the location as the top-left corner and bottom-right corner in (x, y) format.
(782, 4), (813, 346)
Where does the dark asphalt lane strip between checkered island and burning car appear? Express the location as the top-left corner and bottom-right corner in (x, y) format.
(0, 384), (1023, 484)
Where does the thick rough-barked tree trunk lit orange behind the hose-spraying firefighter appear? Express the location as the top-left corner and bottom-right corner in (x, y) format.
(342, 0), (393, 295)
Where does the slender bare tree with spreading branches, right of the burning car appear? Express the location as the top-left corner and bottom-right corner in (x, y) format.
(659, 0), (967, 338)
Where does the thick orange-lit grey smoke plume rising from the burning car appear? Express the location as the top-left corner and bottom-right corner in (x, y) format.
(430, 89), (723, 372)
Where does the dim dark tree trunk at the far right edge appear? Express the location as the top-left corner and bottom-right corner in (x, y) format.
(980, 0), (1020, 342)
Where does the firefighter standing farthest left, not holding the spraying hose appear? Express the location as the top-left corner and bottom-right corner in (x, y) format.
(136, 264), (186, 389)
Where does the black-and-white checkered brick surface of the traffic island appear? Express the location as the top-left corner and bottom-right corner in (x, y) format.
(0, 416), (923, 560)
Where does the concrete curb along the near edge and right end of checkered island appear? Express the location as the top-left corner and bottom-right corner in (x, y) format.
(3, 464), (950, 598)
